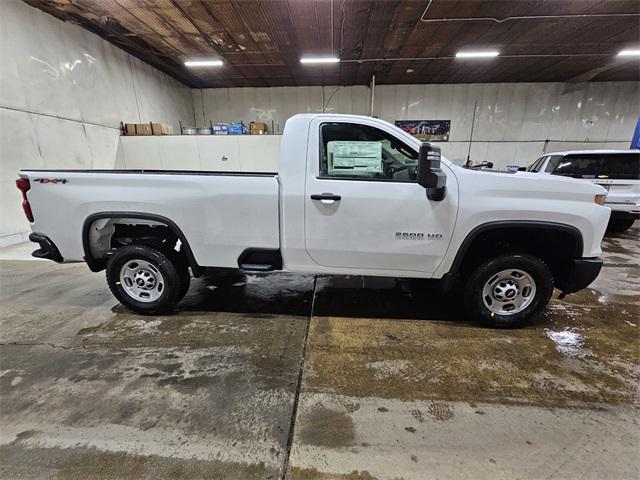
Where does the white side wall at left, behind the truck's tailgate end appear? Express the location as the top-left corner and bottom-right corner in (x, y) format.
(0, 0), (194, 246)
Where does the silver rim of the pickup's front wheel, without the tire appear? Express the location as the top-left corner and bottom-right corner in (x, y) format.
(482, 269), (536, 315)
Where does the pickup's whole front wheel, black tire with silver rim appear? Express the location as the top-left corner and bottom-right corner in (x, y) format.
(464, 254), (553, 327)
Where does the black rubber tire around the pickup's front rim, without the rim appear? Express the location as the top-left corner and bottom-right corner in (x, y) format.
(464, 254), (553, 328)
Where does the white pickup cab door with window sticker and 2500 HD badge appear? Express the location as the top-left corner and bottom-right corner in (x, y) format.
(304, 117), (456, 274)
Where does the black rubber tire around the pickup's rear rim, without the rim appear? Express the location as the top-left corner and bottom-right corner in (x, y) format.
(107, 245), (189, 315)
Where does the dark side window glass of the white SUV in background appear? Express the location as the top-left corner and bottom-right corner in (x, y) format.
(552, 153), (640, 180)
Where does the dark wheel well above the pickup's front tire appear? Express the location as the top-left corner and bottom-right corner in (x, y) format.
(452, 225), (582, 279)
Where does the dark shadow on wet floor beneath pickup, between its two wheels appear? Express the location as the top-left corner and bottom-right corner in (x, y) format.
(178, 270), (462, 320)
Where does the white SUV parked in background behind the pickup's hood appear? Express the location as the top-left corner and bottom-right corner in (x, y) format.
(527, 150), (640, 232)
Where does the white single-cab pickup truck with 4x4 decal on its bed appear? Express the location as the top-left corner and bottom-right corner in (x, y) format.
(17, 114), (610, 326)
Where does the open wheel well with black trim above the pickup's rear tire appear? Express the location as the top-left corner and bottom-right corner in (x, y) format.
(82, 213), (203, 276)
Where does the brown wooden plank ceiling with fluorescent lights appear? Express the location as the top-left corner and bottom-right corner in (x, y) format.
(25, 0), (640, 88)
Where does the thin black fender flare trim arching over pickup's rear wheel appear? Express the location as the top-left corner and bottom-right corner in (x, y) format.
(82, 212), (204, 277)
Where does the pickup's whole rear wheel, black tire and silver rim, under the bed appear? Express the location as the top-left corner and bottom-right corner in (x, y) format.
(107, 245), (189, 315)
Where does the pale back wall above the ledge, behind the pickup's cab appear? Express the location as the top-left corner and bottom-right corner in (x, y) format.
(192, 82), (640, 167)
